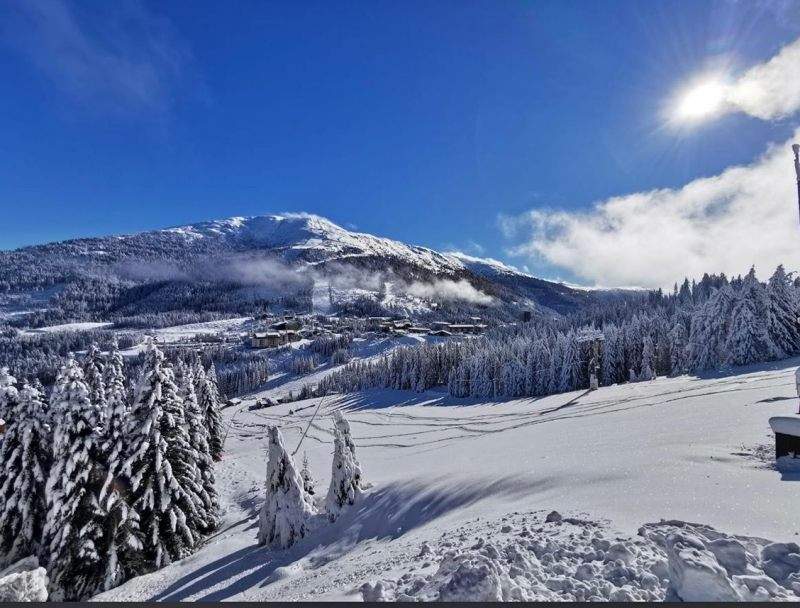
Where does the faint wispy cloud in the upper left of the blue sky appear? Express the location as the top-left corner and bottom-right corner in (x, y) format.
(0, 0), (197, 114)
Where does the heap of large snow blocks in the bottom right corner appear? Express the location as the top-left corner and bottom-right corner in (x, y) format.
(639, 521), (800, 602)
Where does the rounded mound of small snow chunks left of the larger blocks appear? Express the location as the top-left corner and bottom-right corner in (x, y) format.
(360, 513), (667, 602)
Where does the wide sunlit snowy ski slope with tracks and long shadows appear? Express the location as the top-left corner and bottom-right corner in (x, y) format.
(97, 360), (800, 601)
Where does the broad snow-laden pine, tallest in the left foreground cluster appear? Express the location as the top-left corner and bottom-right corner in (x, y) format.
(123, 342), (198, 568)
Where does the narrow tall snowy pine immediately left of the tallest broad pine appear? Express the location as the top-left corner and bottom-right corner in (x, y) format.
(100, 341), (147, 591)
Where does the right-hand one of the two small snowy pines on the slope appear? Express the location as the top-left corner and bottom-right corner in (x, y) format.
(325, 411), (362, 520)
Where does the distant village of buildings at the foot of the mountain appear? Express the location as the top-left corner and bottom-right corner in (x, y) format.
(247, 314), (487, 348)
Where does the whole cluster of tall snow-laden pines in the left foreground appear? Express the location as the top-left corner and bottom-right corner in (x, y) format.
(0, 343), (223, 600)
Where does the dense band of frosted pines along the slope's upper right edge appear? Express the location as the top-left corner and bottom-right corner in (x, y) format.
(316, 266), (800, 397)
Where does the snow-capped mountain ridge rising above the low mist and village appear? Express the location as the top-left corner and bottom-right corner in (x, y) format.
(0, 213), (588, 316)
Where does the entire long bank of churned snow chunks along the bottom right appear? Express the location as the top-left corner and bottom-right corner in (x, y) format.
(360, 511), (800, 602)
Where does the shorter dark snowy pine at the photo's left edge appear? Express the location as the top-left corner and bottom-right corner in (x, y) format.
(0, 384), (51, 569)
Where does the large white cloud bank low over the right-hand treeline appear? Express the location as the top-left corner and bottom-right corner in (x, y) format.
(500, 130), (800, 287)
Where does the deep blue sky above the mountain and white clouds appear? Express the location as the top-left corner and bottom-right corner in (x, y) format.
(0, 0), (800, 284)
